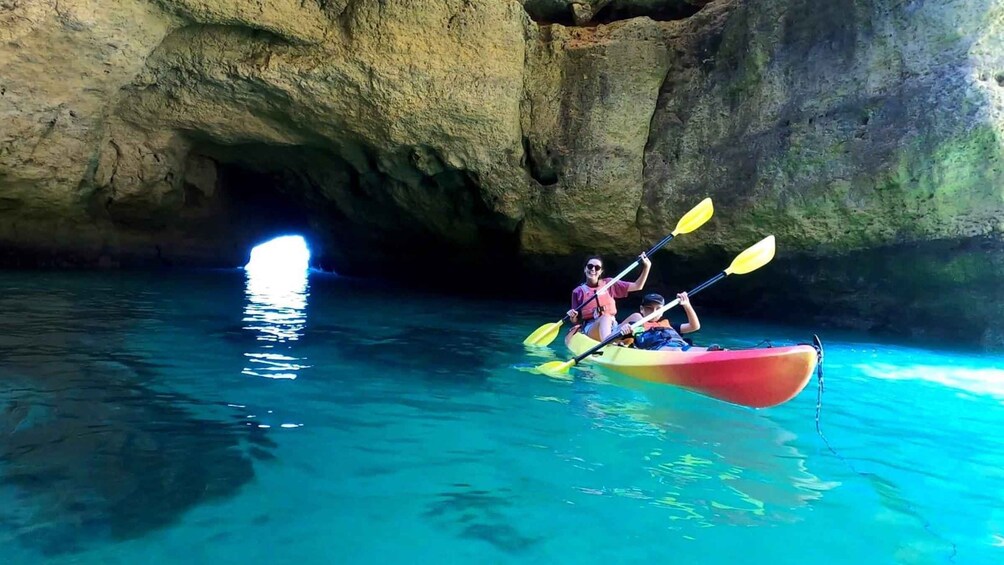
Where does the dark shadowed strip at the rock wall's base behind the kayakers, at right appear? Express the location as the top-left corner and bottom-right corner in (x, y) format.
(526, 238), (1004, 350)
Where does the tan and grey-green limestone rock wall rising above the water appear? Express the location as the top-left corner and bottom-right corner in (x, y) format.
(0, 0), (1004, 342)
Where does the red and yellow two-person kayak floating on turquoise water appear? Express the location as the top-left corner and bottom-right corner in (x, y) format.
(565, 332), (821, 408)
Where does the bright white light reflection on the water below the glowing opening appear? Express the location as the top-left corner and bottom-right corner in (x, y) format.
(242, 263), (310, 378)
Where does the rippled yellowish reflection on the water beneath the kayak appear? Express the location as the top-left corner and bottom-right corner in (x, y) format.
(572, 370), (839, 528)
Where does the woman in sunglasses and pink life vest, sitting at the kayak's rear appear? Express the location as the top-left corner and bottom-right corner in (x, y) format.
(568, 253), (652, 341)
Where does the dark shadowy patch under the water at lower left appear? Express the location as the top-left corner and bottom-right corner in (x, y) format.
(0, 354), (274, 556)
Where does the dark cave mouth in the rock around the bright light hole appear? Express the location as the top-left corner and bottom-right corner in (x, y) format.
(186, 143), (519, 297)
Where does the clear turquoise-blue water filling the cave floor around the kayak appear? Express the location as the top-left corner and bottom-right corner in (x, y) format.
(0, 271), (1004, 565)
